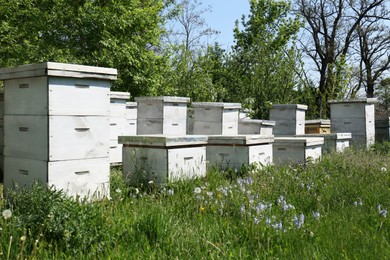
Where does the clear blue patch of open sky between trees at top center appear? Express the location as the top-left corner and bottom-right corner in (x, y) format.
(202, 0), (249, 49)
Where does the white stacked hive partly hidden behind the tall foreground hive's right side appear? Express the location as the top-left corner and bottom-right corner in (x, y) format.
(110, 91), (132, 165)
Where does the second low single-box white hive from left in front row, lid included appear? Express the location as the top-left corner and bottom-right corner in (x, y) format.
(206, 135), (274, 170)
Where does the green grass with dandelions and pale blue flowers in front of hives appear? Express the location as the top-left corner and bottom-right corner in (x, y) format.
(0, 145), (390, 259)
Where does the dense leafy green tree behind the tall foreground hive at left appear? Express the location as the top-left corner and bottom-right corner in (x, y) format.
(0, 0), (166, 96)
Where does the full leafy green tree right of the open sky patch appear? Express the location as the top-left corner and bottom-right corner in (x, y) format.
(226, 0), (301, 119)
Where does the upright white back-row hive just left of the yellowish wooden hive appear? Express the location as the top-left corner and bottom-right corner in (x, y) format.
(269, 104), (307, 135)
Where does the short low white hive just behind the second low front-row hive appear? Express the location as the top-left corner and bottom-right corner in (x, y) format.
(238, 119), (275, 135)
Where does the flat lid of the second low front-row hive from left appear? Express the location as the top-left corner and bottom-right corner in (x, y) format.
(208, 135), (274, 145)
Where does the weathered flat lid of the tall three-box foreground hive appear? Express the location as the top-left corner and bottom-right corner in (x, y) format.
(0, 62), (117, 80)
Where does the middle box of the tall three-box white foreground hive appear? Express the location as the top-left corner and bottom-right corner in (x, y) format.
(4, 115), (109, 161)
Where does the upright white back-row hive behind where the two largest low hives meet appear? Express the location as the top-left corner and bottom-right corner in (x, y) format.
(190, 102), (241, 135)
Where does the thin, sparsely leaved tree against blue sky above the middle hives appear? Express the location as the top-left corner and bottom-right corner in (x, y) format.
(156, 0), (221, 101)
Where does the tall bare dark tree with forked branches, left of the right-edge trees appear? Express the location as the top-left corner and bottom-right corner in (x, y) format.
(297, 0), (385, 117)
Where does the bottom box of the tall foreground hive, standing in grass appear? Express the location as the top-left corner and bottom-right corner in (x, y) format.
(4, 156), (110, 199)
